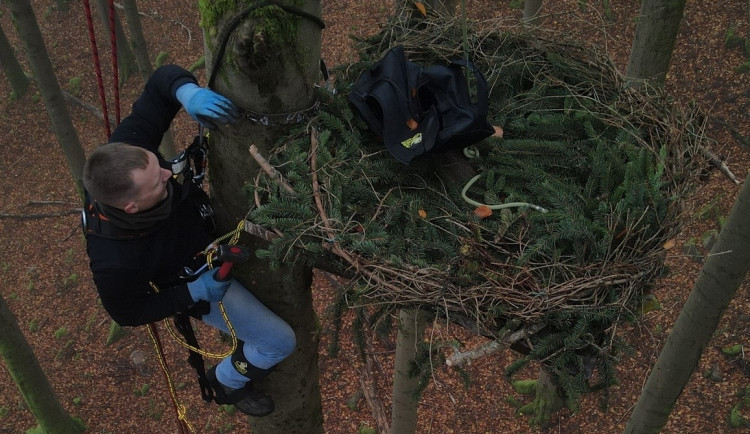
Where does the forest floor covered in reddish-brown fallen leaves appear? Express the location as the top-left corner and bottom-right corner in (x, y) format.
(0, 0), (750, 433)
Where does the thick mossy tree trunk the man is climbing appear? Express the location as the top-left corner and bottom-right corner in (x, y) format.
(201, 0), (323, 434)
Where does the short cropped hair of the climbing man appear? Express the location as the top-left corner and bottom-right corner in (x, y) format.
(83, 142), (149, 207)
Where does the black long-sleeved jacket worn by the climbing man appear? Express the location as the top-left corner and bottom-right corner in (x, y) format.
(86, 65), (213, 326)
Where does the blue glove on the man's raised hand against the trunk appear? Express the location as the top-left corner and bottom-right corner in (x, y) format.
(175, 83), (239, 130)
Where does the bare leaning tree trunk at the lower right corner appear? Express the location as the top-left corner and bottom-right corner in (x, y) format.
(625, 174), (750, 434)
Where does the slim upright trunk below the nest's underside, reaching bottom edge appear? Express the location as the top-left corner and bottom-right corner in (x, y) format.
(391, 309), (425, 434)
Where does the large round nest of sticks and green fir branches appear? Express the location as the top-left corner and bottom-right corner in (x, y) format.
(250, 12), (705, 330)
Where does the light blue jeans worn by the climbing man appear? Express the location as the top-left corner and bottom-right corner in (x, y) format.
(202, 279), (297, 389)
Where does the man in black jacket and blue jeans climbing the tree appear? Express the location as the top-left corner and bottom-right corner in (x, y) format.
(83, 65), (295, 416)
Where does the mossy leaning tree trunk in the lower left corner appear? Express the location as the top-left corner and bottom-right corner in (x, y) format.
(0, 296), (84, 433)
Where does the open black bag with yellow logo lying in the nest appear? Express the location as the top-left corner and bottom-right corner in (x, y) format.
(349, 45), (494, 164)
